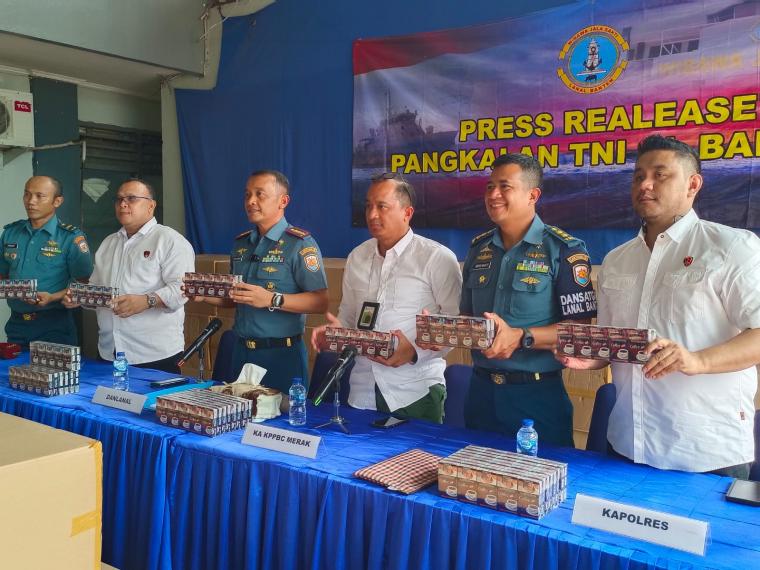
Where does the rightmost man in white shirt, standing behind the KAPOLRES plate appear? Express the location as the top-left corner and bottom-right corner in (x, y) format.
(560, 135), (760, 479)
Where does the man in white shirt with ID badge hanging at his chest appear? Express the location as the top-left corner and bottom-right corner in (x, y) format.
(312, 174), (462, 423)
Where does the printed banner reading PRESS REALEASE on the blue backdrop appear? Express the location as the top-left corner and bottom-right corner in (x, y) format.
(352, 0), (760, 228)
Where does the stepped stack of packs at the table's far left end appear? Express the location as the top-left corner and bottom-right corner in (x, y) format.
(8, 341), (82, 396)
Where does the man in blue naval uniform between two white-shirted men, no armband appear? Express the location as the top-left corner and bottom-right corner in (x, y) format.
(197, 170), (327, 392)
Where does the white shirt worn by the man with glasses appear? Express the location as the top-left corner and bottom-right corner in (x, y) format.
(90, 218), (195, 364)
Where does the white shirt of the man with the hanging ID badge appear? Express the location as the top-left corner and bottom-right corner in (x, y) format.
(338, 230), (462, 410)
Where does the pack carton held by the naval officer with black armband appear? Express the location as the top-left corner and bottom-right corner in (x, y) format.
(417, 315), (496, 349)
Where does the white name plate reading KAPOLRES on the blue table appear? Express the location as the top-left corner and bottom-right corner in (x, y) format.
(572, 493), (710, 556)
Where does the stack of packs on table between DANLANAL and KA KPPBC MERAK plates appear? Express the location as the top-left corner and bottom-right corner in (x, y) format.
(156, 390), (252, 437)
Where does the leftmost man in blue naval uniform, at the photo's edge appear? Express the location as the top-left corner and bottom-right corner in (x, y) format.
(0, 176), (92, 346)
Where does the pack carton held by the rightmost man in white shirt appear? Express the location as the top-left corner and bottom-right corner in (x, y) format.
(557, 323), (657, 364)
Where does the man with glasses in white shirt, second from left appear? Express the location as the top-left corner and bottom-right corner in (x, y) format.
(64, 180), (195, 372)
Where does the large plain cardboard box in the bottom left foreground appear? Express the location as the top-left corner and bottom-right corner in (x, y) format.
(0, 414), (103, 570)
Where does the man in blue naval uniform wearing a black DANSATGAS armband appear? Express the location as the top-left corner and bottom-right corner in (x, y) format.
(460, 154), (596, 446)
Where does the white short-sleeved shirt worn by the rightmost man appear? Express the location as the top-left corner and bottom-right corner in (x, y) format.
(597, 210), (760, 472)
